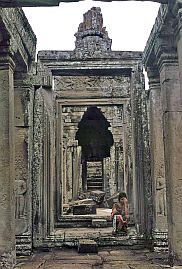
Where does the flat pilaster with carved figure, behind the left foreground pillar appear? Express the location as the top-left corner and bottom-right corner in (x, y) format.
(14, 79), (33, 255)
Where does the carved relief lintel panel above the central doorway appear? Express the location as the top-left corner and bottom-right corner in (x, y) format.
(54, 76), (130, 97)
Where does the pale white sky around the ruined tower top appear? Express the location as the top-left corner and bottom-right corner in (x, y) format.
(24, 0), (159, 51)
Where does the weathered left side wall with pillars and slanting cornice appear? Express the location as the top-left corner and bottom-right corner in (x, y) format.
(0, 6), (36, 268)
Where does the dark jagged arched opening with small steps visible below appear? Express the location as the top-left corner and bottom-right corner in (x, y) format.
(76, 106), (114, 192)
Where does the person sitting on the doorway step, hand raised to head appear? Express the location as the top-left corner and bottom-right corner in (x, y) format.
(111, 192), (129, 234)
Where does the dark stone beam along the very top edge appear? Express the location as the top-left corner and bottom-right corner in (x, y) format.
(0, 0), (168, 7)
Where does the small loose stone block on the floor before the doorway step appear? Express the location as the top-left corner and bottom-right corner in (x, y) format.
(78, 239), (98, 253)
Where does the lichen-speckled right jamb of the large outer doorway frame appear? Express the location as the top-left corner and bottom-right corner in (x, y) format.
(131, 65), (153, 233)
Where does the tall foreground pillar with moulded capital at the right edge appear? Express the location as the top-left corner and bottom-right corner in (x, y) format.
(156, 35), (182, 264)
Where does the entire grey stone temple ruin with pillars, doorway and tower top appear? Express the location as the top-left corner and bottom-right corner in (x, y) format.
(0, 1), (182, 268)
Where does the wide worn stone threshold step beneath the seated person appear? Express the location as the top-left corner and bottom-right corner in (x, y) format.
(38, 227), (149, 249)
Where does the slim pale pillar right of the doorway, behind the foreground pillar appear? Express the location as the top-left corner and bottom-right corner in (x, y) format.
(147, 69), (167, 236)
